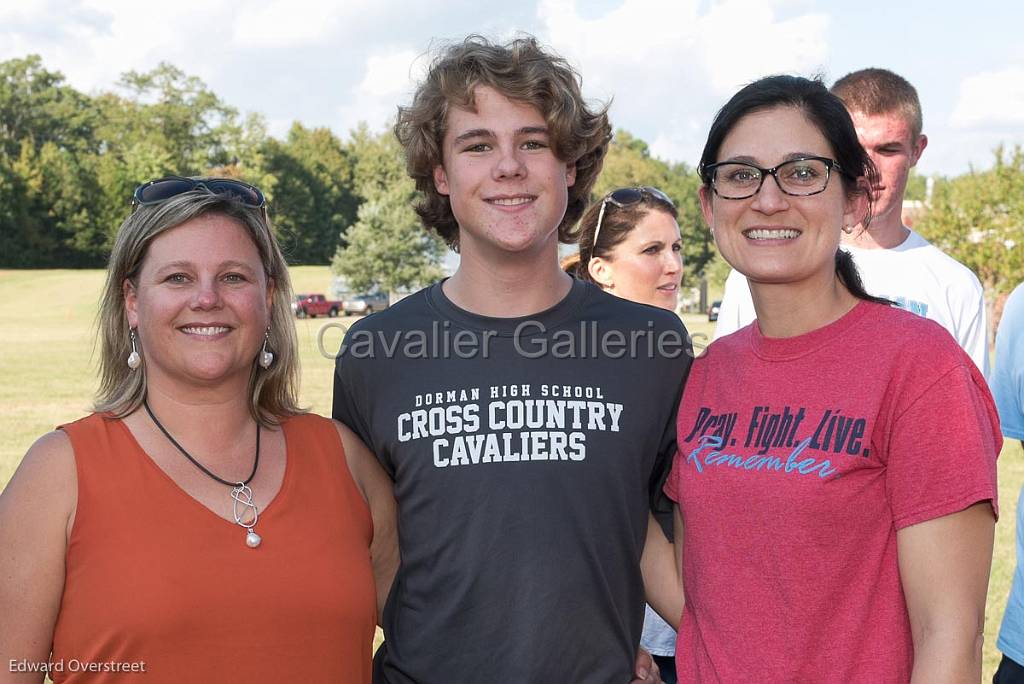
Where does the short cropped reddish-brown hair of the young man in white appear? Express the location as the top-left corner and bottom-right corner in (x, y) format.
(831, 68), (924, 142)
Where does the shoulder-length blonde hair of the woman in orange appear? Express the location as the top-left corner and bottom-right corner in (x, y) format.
(94, 188), (303, 427)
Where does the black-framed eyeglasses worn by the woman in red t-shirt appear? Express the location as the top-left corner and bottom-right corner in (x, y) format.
(700, 157), (843, 200)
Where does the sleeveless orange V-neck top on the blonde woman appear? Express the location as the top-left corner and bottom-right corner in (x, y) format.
(50, 414), (376, 684)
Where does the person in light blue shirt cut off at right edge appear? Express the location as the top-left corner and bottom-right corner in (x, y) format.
(991, 284), (1024, 684)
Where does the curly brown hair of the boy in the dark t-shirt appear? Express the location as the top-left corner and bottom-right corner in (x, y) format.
(394, 35), (611, 250)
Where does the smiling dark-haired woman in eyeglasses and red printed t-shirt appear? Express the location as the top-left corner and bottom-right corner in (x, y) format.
(647, 76), (1000, 683)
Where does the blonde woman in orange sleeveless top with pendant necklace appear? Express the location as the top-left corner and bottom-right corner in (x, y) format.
(0, 177), (397, 683)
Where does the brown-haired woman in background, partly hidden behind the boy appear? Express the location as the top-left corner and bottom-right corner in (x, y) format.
(562, 186), (683, 684)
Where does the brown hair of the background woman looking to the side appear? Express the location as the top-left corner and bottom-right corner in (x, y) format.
(561, 190), (679, 283)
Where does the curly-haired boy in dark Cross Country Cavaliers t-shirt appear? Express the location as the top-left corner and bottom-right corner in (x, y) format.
(333, 37), (690, 684)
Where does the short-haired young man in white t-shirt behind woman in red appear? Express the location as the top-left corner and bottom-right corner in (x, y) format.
(715, 69), (988, 376)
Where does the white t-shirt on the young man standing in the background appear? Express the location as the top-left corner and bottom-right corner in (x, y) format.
(715, 230), (988, 376)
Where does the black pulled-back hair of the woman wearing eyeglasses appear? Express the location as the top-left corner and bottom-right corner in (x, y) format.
(697, 76), (891, 304)
